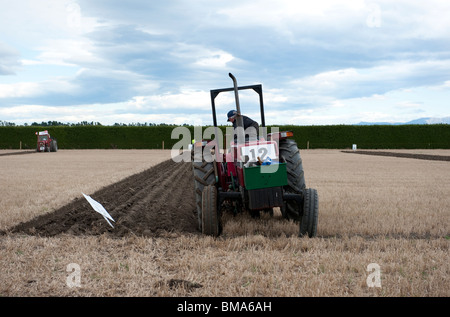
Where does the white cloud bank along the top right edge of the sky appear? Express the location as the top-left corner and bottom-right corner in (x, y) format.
(217, 0), (450, 38)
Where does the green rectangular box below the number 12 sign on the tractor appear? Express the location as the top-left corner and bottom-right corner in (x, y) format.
(244, 163), (287, 190)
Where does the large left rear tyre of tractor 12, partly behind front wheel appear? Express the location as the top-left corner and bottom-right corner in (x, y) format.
(192, 160), (216, 231)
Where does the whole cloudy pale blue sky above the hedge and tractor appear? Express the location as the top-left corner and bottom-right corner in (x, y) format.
(0, 0), (450, 125)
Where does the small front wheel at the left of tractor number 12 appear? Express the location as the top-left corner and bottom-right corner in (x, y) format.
(202, 185), (222, 237)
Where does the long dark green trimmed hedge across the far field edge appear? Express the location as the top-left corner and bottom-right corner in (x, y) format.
(0, 124), (450, 149)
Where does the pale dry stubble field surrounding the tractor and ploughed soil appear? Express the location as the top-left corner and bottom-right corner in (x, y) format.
(0, 150), (450, 297)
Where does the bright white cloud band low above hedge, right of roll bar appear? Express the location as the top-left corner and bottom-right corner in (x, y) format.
(266, 81), (450, 125)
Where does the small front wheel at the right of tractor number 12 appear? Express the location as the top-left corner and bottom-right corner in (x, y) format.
(299, 188), (319, 238)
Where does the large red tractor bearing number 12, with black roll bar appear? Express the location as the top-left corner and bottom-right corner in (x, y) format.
(191, 73), (319, 237)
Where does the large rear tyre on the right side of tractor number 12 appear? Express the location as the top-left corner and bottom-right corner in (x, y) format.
(279, 139), (306, 221)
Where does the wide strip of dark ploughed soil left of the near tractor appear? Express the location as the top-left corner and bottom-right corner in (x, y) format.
(8, 160), (197, 237)
